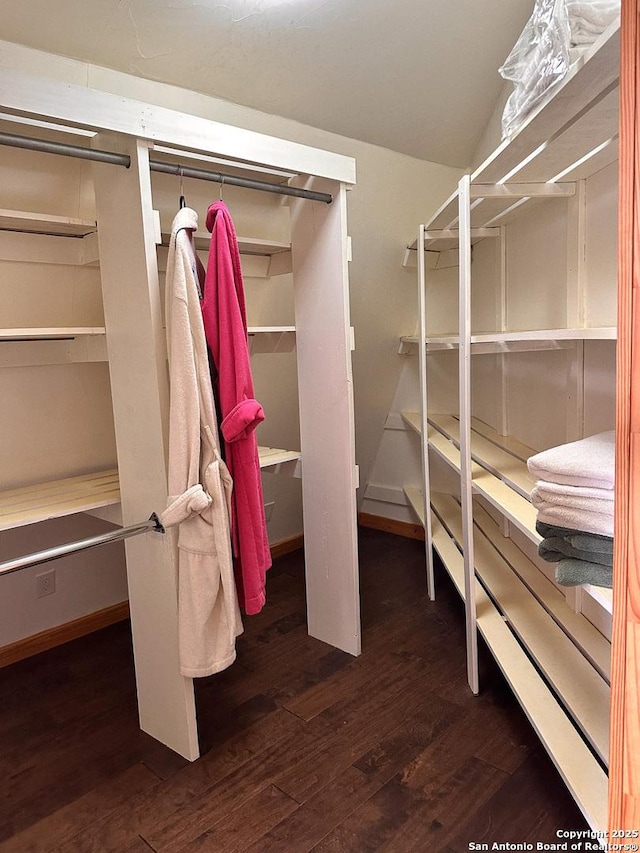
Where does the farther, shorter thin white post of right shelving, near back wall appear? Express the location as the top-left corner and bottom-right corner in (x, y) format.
(417, 225), (436, 601)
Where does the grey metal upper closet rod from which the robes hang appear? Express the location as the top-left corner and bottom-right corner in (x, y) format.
(0, 133), (333, 204)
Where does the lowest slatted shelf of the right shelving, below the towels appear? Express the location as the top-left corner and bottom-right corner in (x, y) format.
(424, 495), (609, 830)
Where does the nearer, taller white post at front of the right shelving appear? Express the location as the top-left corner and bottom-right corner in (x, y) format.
(458, 175), (480, 693)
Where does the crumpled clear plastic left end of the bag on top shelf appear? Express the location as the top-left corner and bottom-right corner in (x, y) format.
(498, 0), (570, 139)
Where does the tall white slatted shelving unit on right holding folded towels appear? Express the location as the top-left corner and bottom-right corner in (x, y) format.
(399, 24), (619, 830)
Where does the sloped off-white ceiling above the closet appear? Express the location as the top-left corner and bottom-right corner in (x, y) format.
(0, 0), (533, 167)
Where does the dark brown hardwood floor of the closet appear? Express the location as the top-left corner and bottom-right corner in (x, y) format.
(0, 530), (586, 853)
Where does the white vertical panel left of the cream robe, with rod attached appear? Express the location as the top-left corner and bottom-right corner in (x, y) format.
(93, 134), (199, 760)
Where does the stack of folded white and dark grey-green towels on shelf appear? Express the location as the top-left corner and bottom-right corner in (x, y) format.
(527, 430), (615, 587)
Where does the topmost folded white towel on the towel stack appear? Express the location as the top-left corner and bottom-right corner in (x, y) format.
(527, 430), (615, 490)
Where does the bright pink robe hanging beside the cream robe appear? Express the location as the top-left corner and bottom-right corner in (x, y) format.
(202, 201), (271, 615)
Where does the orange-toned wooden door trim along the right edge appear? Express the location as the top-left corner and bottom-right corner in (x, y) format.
(609, 0), (640, 832)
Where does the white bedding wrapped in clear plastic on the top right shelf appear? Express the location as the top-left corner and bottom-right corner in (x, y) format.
(499, 0), (620, 139)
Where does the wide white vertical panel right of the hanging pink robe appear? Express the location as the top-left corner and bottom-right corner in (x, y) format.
(291, 179), (360, 655)
